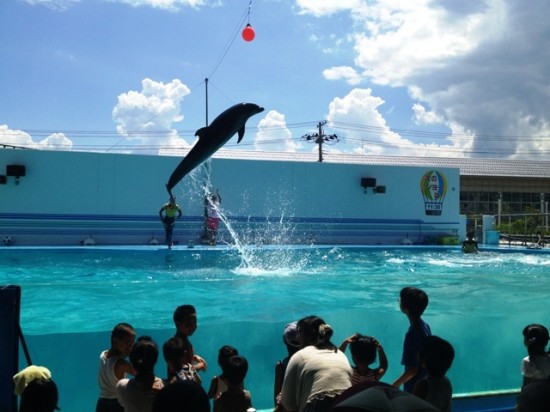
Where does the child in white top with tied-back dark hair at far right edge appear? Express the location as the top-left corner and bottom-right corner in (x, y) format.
(521, 323), (550, 385)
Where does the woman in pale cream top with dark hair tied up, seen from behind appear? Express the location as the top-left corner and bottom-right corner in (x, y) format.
(281, 316), (353, 412)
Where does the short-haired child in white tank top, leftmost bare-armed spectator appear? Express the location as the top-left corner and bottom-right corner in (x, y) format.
(95, 323), (136, 412)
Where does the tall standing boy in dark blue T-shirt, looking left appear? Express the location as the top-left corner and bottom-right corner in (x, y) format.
(393, 286), (432, 392)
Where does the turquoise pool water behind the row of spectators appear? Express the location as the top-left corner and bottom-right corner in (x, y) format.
(0, 247), (550, 411)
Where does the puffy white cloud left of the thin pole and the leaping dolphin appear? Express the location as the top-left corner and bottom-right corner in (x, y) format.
(113, 79), (191, 152)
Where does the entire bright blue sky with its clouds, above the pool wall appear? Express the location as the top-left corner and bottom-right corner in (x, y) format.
(0, 0), (550, 159)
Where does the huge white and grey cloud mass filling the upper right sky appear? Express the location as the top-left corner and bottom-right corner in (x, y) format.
(310, 0), (550, 158)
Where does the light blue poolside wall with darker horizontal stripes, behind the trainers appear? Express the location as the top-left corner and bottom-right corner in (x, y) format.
(0, 149), (463, 245)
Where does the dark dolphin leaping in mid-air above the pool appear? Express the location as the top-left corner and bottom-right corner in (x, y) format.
(166, 103), (264, 198)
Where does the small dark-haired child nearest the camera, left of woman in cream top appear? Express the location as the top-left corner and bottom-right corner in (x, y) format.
(214, 355), (252, 412)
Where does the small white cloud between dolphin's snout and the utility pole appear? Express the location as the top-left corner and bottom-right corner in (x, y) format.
(254, 110), (301, 152)
